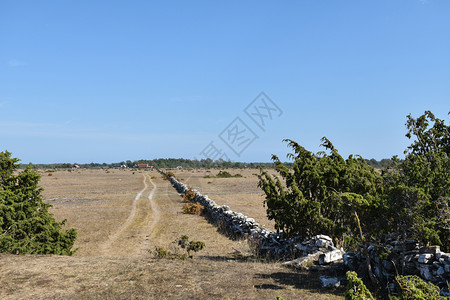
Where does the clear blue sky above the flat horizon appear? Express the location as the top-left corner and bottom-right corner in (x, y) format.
(0, 0), (450, 163)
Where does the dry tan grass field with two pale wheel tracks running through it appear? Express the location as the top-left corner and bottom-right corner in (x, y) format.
(0, 170), (342, 300)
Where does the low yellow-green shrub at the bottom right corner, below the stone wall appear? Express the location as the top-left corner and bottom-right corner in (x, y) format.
(391, 276), (450, 300)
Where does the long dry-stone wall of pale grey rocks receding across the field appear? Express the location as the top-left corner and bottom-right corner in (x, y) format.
(161, 172), (450, 295)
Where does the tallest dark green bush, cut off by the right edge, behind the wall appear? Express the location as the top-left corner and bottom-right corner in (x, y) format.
(383, 111), (450, 251)
